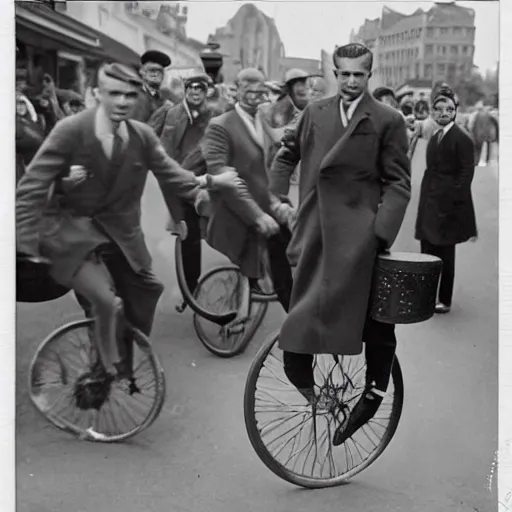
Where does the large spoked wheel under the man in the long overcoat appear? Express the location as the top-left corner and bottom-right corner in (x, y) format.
(244, 334), (403, 488)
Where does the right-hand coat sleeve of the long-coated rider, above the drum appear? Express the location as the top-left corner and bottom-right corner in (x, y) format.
(375, 115), (411, 247)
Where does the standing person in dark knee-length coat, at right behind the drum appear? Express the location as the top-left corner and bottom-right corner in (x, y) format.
(416, 87), (477, 314)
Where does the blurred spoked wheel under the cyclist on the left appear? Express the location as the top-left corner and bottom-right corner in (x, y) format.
(29, 319), (165, 442)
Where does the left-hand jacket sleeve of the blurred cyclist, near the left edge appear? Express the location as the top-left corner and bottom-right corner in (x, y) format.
(16, 118), (80, 256)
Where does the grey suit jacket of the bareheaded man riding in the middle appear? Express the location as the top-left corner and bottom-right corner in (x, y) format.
(201, 105), (276, 277)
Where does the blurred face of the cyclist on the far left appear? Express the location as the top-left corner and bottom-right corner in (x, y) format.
(98, 77), (139, 122)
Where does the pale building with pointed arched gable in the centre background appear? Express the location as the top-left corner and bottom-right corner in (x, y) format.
(212, 4), (284, 83)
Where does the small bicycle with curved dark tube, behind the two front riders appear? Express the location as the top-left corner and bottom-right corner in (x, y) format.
(171, 221), (277, 358)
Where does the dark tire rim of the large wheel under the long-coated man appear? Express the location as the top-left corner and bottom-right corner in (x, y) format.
(244, 333), (404, 489)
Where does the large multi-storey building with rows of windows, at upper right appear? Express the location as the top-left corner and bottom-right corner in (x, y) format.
(352, 2), (475, 88)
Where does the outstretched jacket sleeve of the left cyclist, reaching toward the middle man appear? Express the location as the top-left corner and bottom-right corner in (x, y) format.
(145, 127), (208, 217)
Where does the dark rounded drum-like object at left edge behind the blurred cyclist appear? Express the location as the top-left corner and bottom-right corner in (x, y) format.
(16, 255), (69, 302)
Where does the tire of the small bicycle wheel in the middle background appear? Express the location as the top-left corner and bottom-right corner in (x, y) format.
(193, 265), (268, 359)
